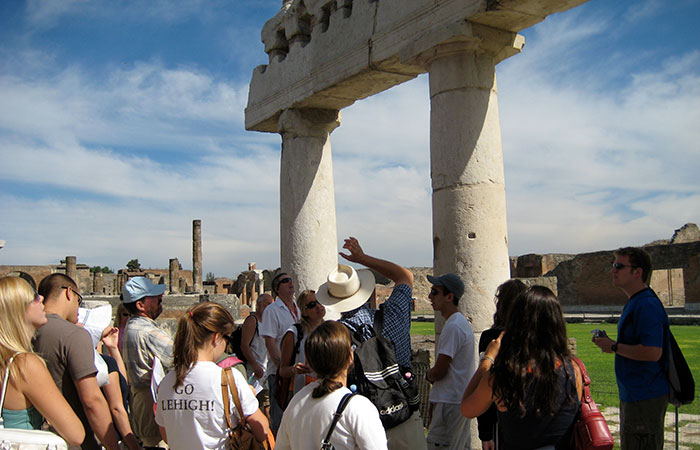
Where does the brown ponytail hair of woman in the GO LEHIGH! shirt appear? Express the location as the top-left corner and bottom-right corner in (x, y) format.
(173, 302), (233, 388)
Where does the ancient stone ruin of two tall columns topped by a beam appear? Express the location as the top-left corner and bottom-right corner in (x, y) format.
(245, 0), (585, 332)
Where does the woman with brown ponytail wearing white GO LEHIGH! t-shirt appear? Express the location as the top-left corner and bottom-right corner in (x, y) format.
(156, 302), (268, 450)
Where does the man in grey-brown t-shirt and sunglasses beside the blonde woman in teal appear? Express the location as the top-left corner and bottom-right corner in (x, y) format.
(34, 273), (119, 450)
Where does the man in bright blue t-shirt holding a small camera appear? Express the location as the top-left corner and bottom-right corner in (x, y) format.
(593, 247), (670, 450)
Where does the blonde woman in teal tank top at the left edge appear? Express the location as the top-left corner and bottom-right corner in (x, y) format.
(0, 277), (85, 445)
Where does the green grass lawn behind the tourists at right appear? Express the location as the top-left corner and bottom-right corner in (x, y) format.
(411, 322), (700, 414)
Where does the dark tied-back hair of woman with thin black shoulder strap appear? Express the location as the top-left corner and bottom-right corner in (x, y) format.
(304, 320), (352, 398)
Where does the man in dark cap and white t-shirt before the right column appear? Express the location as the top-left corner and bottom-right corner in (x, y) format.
(426, 273), (476, 449)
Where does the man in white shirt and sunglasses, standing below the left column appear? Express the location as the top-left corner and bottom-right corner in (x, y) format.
(259, 272), (301, 433)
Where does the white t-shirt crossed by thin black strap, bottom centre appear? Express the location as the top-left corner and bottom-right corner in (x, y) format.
(275, 381), (387, 450)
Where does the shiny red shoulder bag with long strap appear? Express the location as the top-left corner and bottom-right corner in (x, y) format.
(571, 357), (615, 450)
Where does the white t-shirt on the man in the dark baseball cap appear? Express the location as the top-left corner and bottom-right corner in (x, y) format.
(430, 312), (476, 404)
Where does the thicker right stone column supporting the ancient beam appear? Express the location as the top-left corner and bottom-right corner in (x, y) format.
(428, 42), (510, 333)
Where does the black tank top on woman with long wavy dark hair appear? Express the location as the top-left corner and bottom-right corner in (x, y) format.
(498, 361), (581, 450)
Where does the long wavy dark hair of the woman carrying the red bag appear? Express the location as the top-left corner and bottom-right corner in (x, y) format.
(492, 286), (575, 417)
